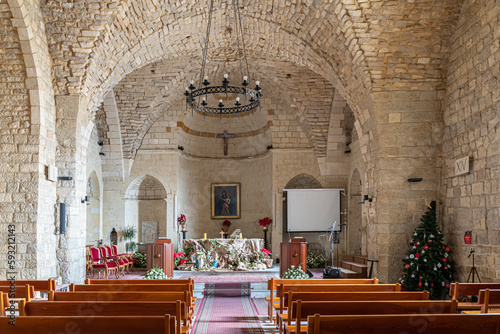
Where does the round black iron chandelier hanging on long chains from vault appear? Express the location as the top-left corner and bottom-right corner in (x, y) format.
(184, 0), (262, 117)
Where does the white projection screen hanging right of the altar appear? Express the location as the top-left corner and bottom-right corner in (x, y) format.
(284, 189), (344, 232)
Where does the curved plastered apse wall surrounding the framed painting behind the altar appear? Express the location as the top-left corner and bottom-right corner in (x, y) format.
(177, 154), (273, 245)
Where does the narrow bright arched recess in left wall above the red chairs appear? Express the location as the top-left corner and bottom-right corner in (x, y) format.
(86, 171), (102, 246)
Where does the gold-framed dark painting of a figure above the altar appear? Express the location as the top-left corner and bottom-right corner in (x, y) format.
(212, 183), (241, 219)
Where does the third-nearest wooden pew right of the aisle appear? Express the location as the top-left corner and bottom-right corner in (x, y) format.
(278, 291), (429, 333)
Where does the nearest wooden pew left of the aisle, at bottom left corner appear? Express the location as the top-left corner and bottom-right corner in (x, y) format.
(0, 315), (176, 334)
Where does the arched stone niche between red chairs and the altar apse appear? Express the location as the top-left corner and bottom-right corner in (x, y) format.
(125, 175), (167, 251)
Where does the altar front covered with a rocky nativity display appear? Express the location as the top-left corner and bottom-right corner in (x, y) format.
(183, 239), (266, 270)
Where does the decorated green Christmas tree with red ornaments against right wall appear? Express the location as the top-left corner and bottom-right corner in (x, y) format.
(399, 202), (453, 299)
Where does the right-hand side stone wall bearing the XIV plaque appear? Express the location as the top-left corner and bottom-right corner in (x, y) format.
(441, 0), (500, 282)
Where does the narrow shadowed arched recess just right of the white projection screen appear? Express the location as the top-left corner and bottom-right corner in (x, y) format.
(347, 169), (366, 255)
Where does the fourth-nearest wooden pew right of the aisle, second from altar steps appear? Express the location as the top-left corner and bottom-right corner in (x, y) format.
(273, 283), (401, 325)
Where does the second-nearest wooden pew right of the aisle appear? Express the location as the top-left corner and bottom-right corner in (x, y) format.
(286, 299), (457, 334)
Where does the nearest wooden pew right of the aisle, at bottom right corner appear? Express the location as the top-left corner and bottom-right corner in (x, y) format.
(307, 314), (500, 334)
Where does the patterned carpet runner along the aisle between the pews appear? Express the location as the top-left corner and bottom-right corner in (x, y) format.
(193, 282), (264, 334)
